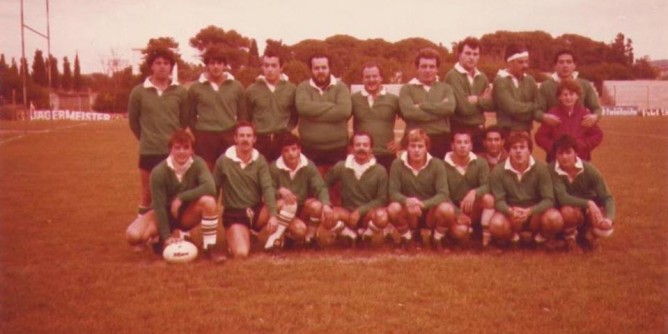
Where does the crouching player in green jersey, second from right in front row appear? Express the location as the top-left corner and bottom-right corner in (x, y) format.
(489, 132), (564, 247)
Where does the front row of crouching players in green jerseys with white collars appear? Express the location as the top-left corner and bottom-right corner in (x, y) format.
(127, 126), (615, 261)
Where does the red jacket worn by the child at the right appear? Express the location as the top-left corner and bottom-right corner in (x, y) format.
(536, 105), (603, 162)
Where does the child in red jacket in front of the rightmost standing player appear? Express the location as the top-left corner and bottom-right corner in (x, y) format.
(536, 80), (603, 162)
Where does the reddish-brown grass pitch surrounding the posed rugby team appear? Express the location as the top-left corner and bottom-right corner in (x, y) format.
(0, 117), (668, 333)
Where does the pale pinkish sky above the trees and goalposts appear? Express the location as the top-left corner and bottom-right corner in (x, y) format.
(0, 0), (668, 73)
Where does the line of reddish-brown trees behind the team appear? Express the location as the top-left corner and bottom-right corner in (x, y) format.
(0, 25), (658, 112)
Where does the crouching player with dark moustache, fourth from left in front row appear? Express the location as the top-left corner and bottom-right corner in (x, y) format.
(323, 131), (388, 247)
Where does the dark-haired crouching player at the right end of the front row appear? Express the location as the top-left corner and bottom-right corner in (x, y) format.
(550, 135), (615, 246)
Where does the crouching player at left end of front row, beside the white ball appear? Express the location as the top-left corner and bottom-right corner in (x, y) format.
(126, 130), (224, 261)
